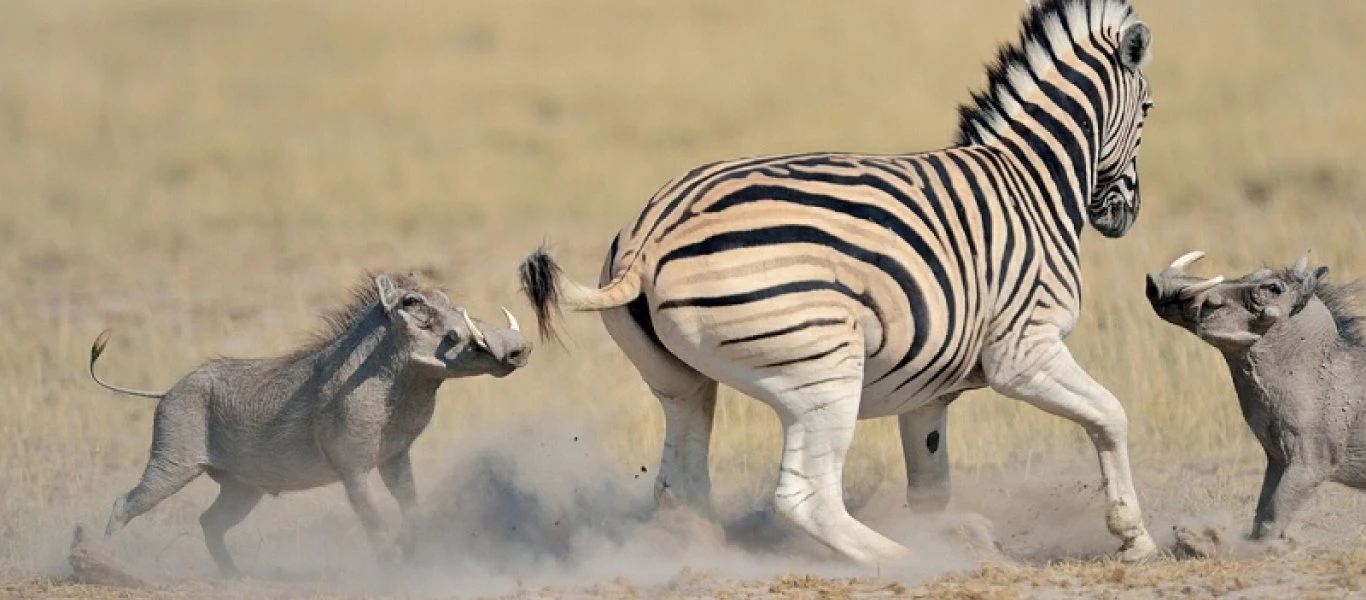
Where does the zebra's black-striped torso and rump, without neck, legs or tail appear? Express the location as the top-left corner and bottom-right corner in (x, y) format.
(625, 148), (1079, 418)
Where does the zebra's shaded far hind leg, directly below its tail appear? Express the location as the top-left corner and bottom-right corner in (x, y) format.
(602, 309), (717, 518)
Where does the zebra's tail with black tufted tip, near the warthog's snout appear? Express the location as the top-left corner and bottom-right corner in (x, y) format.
(520, 246), (641, 339)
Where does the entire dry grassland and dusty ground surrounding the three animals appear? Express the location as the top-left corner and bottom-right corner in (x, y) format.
(8, 0), (1366, 599)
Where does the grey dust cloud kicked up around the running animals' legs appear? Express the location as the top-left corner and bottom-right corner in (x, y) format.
(48, 418), (1294, 596)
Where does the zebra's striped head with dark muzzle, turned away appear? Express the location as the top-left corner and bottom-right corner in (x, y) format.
(1086, 21), (1153, 238)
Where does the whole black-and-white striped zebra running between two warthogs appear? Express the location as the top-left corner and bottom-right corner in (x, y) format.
(519, 0), (1156, 563)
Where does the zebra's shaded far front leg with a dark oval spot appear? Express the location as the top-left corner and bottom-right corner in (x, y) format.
(897, 394), (958, 515)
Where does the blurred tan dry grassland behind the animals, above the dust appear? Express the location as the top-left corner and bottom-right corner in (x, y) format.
(0, 0), (1366, 570)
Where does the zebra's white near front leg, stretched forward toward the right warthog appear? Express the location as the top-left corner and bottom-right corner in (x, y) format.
(984, 339), (1157, 562)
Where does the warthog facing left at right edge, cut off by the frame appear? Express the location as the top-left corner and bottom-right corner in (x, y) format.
(1147, 251), (1366, 540)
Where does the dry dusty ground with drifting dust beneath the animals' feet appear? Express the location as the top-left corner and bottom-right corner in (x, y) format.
(13, 425), (1366, 599)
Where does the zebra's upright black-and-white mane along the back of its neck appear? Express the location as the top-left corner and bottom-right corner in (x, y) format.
(953, 0), (1134, 145)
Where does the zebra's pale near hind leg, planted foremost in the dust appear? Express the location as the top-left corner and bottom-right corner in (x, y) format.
(761, 374), (907, 563)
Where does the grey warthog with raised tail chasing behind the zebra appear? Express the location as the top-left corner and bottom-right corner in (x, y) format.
(90, 275), (531, 575)
